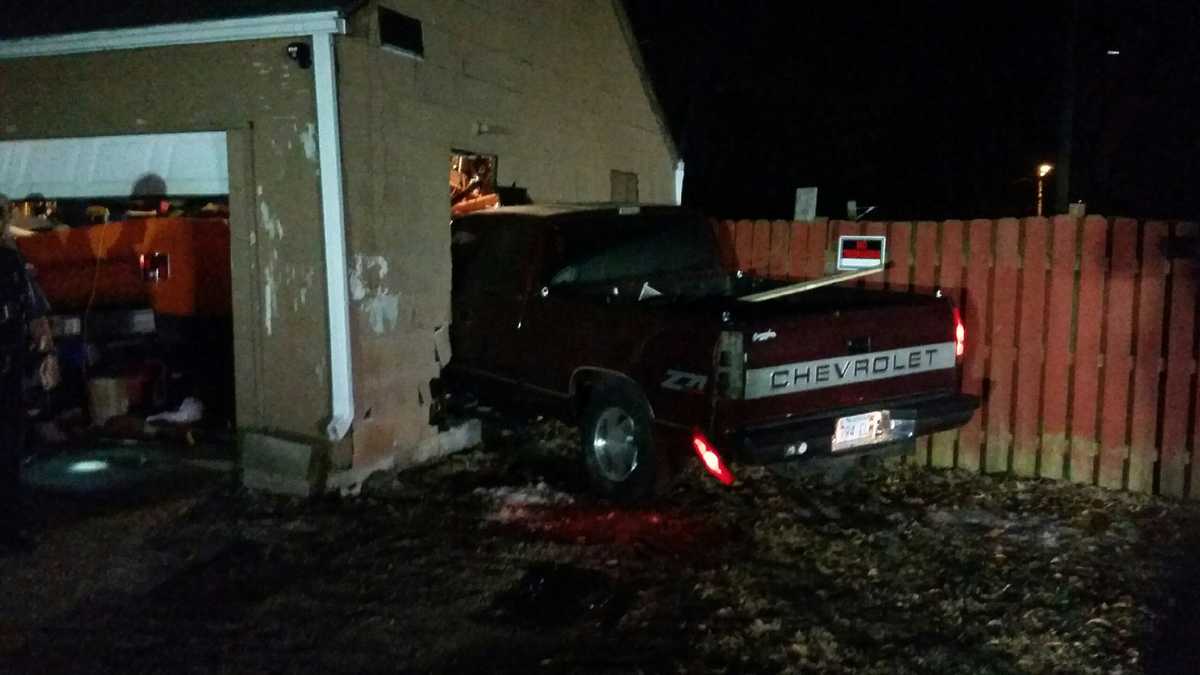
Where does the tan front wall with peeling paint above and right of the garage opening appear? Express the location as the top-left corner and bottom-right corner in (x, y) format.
(0, 41), (330, 437)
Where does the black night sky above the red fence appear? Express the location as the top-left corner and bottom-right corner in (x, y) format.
(626, 0), (1200, 220)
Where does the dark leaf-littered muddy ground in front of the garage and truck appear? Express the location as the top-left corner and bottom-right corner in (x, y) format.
(0, 424), (1200, 674)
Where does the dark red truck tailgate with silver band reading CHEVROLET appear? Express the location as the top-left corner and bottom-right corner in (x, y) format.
(720, 288), (958, 428)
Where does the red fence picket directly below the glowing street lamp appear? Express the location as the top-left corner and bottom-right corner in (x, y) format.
(1013, 217), (1049, 476)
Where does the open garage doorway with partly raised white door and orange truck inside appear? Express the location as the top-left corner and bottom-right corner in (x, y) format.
(0, 133), (236, 466)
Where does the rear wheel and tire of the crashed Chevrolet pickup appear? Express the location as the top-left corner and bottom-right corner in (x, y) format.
(580, 382), (659, 503)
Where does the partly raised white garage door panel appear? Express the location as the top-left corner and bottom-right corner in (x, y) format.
(0, 132), (229, 199)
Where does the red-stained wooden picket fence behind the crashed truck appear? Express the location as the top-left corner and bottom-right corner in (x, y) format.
(716, 216), (1200, 498)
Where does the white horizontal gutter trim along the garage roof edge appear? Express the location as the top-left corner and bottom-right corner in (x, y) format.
(0, 12), (346, 60)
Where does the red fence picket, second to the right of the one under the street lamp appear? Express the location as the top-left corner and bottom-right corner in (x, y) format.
(1069, 216), (1108, 483)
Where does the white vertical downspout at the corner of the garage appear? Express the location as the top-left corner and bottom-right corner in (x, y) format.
(312, 32), (354, 441)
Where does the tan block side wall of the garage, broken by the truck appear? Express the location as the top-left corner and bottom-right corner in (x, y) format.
(337, 0), (674, 466)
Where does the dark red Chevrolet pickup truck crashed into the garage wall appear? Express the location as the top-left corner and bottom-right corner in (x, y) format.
(443, 205), (979, 501)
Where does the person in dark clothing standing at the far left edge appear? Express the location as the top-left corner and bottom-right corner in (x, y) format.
(0, 195), (59, 550)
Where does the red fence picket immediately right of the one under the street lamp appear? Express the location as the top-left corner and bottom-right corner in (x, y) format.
(1038, 216), (1079, 478)
